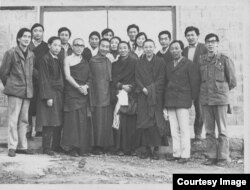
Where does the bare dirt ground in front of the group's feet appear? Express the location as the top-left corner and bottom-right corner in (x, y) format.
(0, 144), (244, 184)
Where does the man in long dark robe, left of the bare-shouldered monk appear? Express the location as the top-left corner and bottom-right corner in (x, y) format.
(36, 36), (63, 155)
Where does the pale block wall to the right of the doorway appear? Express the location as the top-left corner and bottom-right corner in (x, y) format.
(177, 6), (246, 125)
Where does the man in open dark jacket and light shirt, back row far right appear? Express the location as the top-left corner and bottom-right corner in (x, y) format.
(183, 26), (207, 142)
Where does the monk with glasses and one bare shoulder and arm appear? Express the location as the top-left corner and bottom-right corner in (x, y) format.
(62, 38), (93, 156)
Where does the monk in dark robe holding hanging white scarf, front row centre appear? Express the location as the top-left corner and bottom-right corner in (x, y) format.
(111, 41), (137, 156)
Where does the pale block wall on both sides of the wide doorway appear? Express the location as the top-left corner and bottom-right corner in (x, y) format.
(0, 0), (244, 126)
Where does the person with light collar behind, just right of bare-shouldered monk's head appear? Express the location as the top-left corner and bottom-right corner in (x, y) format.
(82, 31), (101, 62)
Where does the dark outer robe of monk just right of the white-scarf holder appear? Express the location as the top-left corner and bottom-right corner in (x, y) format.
(135, 55), (166, 136)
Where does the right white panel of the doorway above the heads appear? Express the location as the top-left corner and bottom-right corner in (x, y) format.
(109, 10), (173, 49)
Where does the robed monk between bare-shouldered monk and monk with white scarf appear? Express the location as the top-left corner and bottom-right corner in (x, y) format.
(89, 39), (114, 154)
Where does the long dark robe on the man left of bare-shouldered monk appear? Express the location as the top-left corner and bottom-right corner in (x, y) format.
(37, 53), (63, 126)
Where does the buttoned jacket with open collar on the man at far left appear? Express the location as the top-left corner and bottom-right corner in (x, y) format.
(0, 46), (35, 99)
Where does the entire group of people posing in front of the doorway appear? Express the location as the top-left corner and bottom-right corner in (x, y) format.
(0, 23), (236, 165)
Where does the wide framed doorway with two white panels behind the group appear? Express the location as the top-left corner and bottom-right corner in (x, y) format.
(41, 6), (176, 49)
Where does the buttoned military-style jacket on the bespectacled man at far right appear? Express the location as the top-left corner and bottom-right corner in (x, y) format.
(199, 53), (236, 105)
